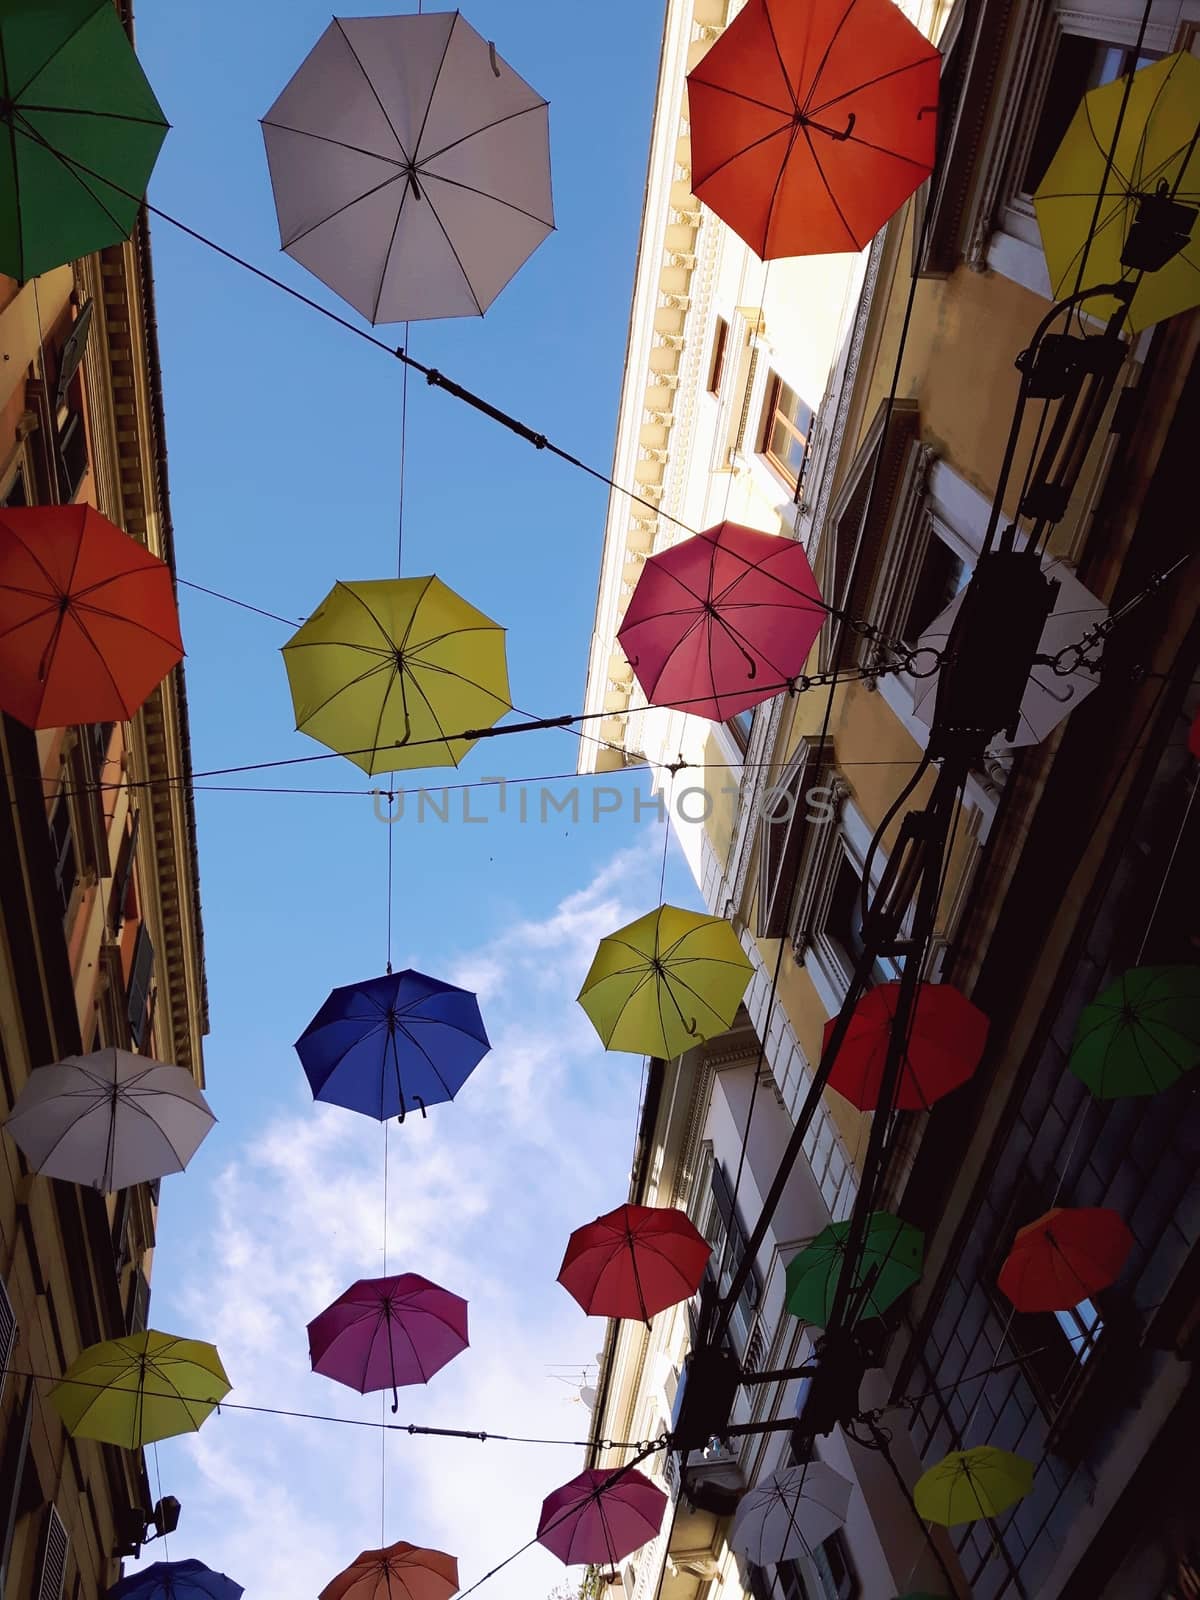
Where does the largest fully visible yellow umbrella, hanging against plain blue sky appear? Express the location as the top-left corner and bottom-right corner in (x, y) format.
(283, 578), (512, 773)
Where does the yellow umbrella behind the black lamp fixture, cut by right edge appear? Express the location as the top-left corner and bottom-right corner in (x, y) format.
(1034, 50), (1200, 333)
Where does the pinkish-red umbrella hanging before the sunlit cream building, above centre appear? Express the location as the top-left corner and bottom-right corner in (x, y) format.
(616, 522), (826, 722)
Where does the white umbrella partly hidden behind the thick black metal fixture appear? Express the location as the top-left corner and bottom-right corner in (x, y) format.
(912, 562), (1109, 750)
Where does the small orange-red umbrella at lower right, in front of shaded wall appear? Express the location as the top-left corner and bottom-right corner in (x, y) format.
(997, 1206), (1133, 1310)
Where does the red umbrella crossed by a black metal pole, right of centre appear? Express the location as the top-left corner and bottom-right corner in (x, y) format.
(826, 984), (987, 1110)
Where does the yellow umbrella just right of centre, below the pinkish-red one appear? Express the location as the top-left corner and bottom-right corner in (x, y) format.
(579, 906), (752, 1058)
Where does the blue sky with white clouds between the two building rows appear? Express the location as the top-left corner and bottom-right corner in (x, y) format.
(128, 0), (694, 1600)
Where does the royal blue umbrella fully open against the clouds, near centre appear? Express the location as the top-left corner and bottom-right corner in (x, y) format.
(296, 971), (491, 1122)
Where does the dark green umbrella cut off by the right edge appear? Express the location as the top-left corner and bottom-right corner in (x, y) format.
(1069, 966), (1200, 1099)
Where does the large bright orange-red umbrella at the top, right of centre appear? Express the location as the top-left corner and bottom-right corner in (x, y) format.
(688, 0), (941, 261)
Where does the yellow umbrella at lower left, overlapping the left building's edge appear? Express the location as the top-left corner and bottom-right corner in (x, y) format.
(50, 1330), (230, 1450)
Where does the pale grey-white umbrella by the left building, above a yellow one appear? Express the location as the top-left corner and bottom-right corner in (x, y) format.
(5, 1050), (216, 1194)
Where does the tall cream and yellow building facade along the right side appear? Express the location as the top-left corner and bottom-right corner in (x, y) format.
(581, 0), (1200, 1600)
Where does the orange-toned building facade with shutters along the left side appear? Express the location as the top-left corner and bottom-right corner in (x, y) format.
(0, 131), (208, 1600)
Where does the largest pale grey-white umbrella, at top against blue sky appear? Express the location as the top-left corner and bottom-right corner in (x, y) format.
(262, 11), (554, 323)
